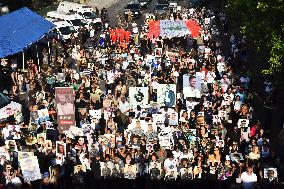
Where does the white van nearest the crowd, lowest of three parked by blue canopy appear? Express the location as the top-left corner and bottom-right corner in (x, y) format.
(47, 21), (78, 41)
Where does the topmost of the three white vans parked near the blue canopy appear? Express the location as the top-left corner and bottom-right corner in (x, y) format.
(57, 1), (101, 24)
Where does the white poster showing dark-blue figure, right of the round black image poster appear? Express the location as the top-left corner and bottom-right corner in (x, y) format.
(157, 84), (176, 107)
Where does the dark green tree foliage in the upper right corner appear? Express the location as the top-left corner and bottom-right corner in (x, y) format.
(226, 0), (284, 77)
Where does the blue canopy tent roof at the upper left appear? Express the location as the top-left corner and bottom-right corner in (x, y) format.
(0, 7), (54, 58)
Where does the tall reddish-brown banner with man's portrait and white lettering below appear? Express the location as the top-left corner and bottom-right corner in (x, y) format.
(55, 87), (75, 133)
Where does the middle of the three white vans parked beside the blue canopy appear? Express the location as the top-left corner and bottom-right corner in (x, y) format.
(47, 11), (87, 31)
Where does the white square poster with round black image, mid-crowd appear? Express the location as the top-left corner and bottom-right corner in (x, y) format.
(129, 87), (148, 109)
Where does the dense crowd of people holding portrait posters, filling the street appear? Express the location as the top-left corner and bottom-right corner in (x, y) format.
(0, 2), (284, 189)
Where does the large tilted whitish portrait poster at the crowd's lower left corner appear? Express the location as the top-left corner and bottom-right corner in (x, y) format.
(19, 156), (41, 182)
